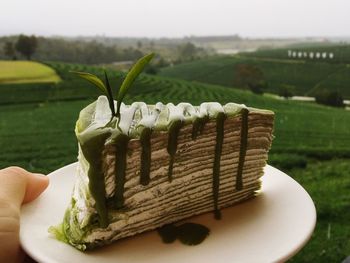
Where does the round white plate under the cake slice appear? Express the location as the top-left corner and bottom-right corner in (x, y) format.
(20, 164), (316, 263)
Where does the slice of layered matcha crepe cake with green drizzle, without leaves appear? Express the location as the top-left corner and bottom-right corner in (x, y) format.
(50, 53), (274, 250)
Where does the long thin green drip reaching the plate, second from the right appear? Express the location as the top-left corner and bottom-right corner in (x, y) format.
(213, 112), (226, 219)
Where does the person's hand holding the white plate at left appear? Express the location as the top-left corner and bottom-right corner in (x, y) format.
(0, 167), (49, 262)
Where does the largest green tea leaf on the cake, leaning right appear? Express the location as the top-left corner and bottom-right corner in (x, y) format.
(116, 53), (154, 117)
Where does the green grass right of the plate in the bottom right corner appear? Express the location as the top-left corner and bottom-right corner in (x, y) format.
(289, 159), (350, 263)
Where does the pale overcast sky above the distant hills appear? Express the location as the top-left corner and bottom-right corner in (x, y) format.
(0, 0), (350, 37)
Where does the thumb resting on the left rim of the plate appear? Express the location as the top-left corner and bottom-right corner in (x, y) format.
(0, 167), (49, 209)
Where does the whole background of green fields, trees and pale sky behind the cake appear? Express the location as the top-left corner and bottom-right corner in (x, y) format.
(0, 0), (350, 262)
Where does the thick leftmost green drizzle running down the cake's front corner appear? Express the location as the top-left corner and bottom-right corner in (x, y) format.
(79, 133), (110, 228)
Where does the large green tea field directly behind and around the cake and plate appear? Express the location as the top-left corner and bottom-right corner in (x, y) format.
(0, 63), (350, 262)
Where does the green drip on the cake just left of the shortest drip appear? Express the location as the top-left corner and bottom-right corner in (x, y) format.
(167, 120), (183, 182)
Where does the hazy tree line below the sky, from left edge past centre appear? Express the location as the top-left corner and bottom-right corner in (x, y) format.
(0, 35), (207, 66)
